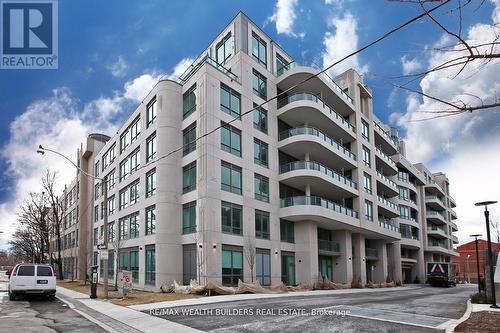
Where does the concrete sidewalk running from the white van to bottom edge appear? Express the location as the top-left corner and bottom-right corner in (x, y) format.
(56, 287), (201, 333)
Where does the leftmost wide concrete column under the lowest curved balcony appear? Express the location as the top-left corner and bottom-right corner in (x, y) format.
(295, 221), (319, 284)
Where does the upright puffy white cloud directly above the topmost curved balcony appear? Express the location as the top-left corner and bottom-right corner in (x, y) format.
(322, 12), (368, 76)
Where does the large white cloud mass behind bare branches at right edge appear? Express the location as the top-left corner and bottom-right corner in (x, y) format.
(390, 0), (500, 242)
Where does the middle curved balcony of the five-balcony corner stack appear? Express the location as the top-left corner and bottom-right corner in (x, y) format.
(278, 127), (356, 170)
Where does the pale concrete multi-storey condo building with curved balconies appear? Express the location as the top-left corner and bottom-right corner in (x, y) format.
(49, 13), (457, 290)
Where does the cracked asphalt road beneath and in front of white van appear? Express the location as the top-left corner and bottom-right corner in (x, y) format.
(0, 272), (106, 333)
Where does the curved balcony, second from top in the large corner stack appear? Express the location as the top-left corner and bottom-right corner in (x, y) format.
(277, 92), (356, 142)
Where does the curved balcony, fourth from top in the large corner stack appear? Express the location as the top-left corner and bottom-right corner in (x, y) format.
(279, 161), (358, 200)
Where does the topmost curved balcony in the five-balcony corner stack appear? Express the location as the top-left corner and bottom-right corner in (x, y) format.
(276, 64), (354, 115)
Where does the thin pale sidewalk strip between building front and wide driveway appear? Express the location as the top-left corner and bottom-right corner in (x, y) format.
(128, 285), (422, 311)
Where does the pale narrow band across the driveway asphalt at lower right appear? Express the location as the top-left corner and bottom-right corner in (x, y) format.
(322, 305), (453, 329)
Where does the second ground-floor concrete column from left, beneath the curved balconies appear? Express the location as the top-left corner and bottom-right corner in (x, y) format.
(333, 230), (353, 283)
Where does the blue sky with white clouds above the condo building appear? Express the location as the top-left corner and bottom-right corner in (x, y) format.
(0, 0), (500, 248)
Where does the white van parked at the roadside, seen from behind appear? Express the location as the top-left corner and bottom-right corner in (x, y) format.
(5, 264), (56, 301)
